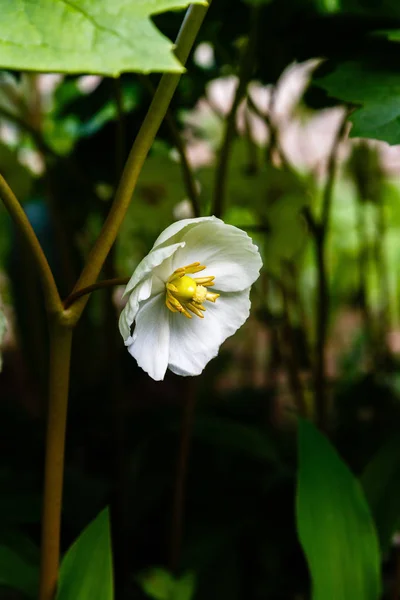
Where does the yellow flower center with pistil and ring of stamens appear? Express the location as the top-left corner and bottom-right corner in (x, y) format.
(165, 262), (219, 319)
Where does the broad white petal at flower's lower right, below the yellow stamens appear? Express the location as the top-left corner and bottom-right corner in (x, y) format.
(169, 288), (250, 375)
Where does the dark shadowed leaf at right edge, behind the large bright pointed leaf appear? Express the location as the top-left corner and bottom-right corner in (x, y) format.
(361, 435), (400, 554)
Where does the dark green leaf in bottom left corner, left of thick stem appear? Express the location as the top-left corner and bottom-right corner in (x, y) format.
(0, 545), (39, 598)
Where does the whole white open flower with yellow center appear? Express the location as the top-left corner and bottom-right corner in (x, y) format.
(119, 217), (262, 381)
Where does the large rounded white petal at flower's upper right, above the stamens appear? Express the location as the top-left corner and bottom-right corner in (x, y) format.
(172, 221), (262, 292)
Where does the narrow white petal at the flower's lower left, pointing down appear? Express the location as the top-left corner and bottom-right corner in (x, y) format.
(128, 293), (172, 381)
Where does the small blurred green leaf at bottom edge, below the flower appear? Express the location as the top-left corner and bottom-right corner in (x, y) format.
(138, 567), (196, 600)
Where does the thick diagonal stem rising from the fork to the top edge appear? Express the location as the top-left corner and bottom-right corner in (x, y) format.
(71, 4), (209, 322)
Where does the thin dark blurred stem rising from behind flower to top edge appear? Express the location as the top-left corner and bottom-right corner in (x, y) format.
(213, 9), (258, 217)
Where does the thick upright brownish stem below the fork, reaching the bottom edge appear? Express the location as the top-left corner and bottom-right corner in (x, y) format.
(39, 320), (72, 600)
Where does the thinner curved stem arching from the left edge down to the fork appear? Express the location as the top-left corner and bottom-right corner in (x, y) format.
(0, 175), (63, 313)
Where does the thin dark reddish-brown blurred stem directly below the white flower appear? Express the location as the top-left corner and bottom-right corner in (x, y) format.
(168, 378), (196, 572)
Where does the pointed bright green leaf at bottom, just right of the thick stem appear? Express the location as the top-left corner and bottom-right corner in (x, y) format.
(56, 509), (114, 600)
